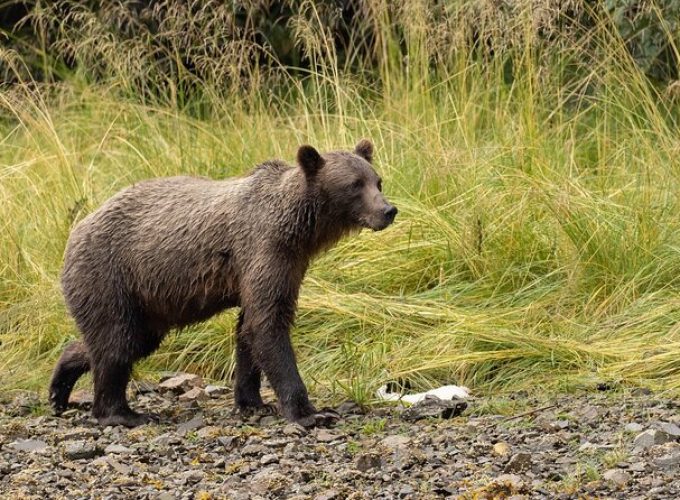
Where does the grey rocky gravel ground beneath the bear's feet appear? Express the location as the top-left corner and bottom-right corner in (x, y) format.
(0, 375), (680, 500)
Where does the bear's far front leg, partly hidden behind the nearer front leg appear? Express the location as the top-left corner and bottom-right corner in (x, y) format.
(234, 312), (277, 416)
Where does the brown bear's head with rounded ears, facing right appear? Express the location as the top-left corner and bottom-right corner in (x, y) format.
(297, 139), (397, 231)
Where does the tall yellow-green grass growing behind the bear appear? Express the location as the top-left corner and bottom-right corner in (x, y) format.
(0, 2), (680, 401)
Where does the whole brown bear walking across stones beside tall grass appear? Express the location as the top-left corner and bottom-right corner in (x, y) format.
(50, 140), (397, 427)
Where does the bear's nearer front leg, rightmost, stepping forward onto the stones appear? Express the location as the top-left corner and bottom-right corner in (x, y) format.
(243, 296), (339, 427)
